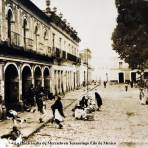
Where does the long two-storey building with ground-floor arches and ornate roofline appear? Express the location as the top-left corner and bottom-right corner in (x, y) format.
(0, 0), (80, 108)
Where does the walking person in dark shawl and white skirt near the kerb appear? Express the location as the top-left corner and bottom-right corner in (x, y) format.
(51, 96), (65, 129)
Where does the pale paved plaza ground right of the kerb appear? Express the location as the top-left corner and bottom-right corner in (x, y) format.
(24, 85), (148, 147)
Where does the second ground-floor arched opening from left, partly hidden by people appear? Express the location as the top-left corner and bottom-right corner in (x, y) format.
(22, 66), (32, 99)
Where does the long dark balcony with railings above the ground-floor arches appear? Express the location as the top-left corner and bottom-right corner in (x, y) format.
(0, 32), (53, 63)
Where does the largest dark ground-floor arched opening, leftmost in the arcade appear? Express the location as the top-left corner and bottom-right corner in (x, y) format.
(5, 64), (19, 110)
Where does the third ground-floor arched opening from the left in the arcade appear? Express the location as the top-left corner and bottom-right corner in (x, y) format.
(34, 67), (42, 87)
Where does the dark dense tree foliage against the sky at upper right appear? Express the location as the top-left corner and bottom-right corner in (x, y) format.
(112, 0), (148, 69)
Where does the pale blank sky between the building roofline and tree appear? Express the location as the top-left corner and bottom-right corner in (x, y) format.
(32, 0), (117, 66)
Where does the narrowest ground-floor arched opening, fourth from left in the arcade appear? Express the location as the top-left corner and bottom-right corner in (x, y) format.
(44, 68), (50, 92)
